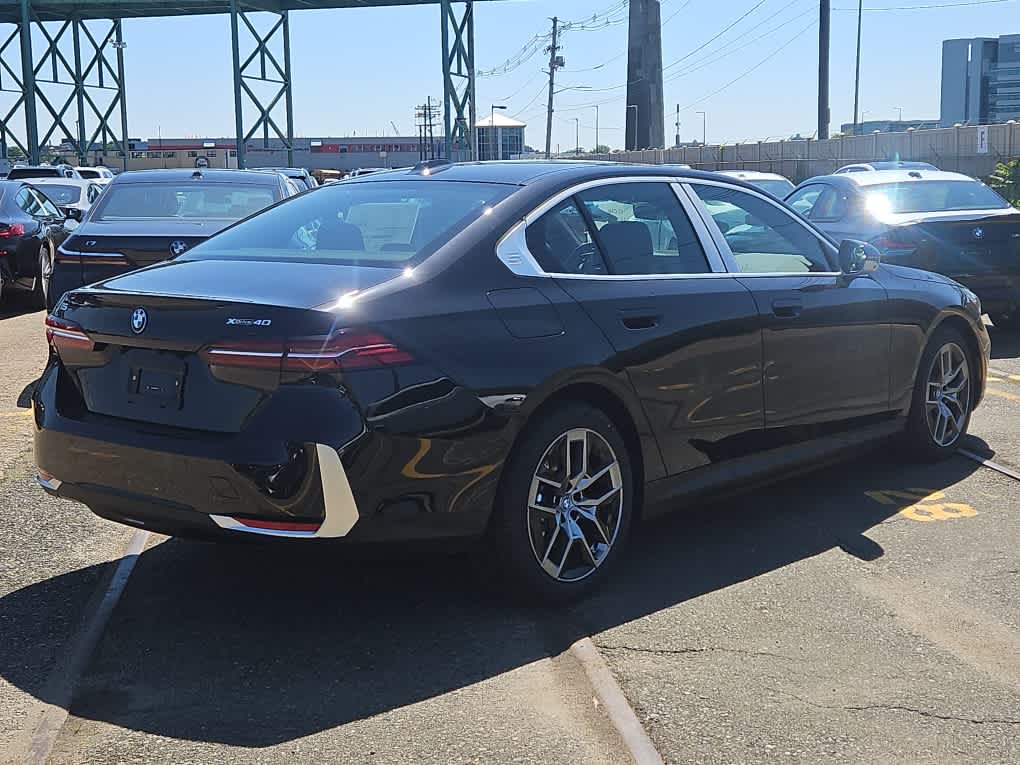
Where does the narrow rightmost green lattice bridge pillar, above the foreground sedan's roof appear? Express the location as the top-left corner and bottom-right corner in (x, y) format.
(440, 0), (477, 160)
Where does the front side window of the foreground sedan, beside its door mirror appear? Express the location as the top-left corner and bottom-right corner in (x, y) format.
(692, 184), (834, 273)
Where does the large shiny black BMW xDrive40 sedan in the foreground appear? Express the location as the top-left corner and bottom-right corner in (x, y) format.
(34, 162), (989, 600)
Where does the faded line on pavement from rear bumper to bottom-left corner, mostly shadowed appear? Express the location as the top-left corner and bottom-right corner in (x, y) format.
(20, 530), (149, 765)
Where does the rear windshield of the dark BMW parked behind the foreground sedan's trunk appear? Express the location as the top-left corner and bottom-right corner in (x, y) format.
(92, 183), (276, 220)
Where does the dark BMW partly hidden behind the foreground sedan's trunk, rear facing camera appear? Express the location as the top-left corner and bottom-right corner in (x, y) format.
(51, 169), (292, 312)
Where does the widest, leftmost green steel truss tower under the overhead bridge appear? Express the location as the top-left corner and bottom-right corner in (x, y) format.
(0, 0), (129, 167)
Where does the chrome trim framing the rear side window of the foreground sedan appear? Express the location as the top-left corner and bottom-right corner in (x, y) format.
(496, 175), (743, 282)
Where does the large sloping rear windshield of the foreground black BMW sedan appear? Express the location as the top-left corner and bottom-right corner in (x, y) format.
(189, 181), (514, 266)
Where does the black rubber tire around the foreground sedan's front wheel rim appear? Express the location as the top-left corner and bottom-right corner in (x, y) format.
(905, 326), (977, 462)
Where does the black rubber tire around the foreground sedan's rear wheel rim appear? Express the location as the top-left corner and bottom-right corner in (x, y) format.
(485, 402), (635, 603)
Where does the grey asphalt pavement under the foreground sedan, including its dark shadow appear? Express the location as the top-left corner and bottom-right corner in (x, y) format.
(0, 313), (1020, 765)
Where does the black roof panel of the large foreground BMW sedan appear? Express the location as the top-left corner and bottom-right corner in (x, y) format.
(344, 159), (741, 186)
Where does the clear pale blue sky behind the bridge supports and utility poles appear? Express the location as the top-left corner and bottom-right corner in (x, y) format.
(109, 0), (1020, 150)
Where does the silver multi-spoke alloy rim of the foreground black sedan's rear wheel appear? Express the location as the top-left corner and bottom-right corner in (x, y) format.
(527, 427), (623, 582)
